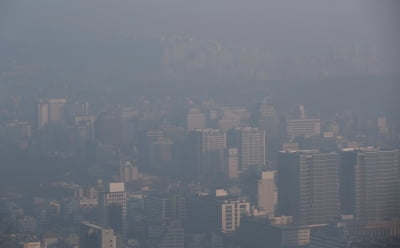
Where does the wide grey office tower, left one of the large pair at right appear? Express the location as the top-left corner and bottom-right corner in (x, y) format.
(277, 150), (339, 225)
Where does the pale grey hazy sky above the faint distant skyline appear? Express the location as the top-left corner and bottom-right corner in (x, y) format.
(0, 0), (400, 47)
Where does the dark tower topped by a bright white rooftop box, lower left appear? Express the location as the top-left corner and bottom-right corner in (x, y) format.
(98, 183), (127, 234)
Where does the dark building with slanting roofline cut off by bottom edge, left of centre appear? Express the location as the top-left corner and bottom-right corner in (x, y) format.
(79, 222), (117, 248)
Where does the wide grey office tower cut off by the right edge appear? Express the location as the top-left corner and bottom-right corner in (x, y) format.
(354, 148), (400, 221)
